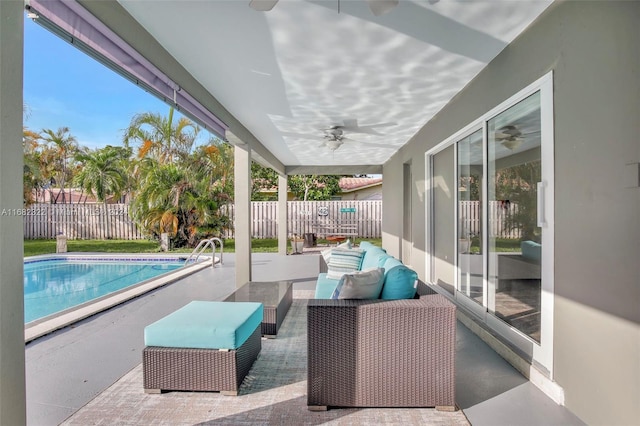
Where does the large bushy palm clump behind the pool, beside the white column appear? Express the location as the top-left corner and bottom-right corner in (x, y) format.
(124, 108), (233, 246)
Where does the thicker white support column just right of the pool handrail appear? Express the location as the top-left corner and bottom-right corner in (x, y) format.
(234, 141), (251, 287)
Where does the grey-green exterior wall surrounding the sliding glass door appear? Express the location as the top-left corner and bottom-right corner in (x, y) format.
(383, 1), (640, 424)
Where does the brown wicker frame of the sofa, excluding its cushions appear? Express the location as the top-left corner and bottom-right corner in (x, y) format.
(307, 243), (456, 411)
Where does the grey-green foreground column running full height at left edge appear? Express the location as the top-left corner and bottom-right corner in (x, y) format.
(0, 0), (27, 425)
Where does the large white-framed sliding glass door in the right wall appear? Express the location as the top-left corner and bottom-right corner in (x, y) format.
(426, 75), (553, 371)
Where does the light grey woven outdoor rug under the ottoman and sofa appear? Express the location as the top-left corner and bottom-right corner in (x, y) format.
(62, 291), (469, 426)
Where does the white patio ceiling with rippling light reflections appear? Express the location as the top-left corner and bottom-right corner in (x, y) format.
(104, 0), (551, 170)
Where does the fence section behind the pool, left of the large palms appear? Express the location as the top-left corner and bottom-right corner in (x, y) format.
(20, 204), (145, 240)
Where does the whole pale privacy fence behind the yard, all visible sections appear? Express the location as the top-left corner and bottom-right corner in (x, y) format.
(23, 200), (382, 240)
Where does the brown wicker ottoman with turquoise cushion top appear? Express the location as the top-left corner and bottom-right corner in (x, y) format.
(142, 301), (263, 395)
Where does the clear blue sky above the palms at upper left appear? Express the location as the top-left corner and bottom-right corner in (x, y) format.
(24, 18), (198, 148)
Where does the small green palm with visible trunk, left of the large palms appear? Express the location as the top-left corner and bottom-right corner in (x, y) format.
(74, 145), (131, 238)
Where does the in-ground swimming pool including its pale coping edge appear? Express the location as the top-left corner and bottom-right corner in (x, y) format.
(24, 255), (211, 340)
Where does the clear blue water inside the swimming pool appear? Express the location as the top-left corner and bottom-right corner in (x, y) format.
(24, 259), (184, 323)
